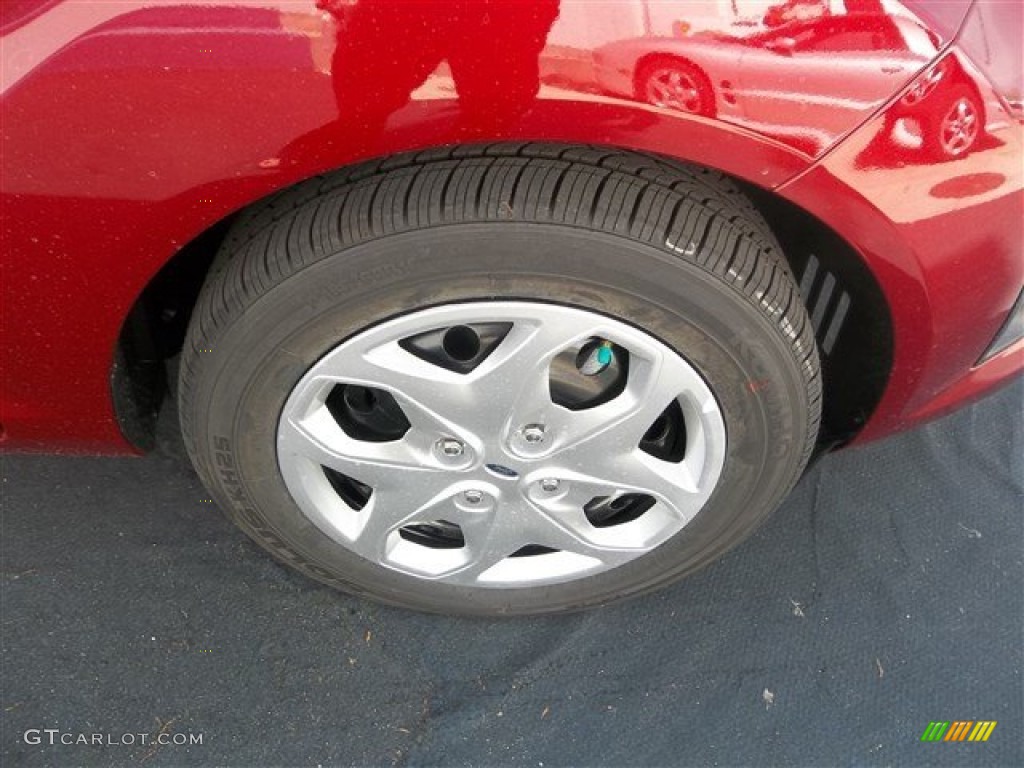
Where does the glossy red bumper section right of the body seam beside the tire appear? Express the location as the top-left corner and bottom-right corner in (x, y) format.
(779, 37), (1024, 440)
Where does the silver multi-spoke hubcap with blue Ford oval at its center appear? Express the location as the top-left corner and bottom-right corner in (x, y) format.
(278, 302), (726, 587)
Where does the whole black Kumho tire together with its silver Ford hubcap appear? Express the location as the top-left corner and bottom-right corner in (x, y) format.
(179, 144), (820, 614)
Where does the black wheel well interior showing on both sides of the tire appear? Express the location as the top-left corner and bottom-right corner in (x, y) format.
(112, 147), (893, 451)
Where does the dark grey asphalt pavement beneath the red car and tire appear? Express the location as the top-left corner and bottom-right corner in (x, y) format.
(0, 382), (1024, 767)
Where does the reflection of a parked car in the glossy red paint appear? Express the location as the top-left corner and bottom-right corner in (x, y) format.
(594, 12), (984, 157)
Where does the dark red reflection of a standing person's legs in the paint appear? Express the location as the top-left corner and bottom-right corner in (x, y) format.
(317, 0), (558, 135)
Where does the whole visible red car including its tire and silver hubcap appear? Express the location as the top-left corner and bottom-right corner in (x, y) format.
(0, 0), (1024, 614)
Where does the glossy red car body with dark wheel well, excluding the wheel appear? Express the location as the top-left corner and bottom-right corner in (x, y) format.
(0, 0), (1024, 454)
